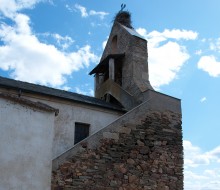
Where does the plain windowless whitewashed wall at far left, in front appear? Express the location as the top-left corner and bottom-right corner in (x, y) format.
(0, 98), (55, 190)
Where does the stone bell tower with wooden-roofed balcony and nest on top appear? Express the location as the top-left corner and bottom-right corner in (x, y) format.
(89, 11), (153, 110)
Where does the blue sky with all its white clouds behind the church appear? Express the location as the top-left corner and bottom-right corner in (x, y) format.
(0, 0), (220, 190)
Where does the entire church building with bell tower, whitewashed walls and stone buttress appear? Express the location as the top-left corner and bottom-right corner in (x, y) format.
(0, 10), (183, 190)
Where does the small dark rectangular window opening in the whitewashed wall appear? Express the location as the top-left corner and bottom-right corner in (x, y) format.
(74, 123), (90, 144)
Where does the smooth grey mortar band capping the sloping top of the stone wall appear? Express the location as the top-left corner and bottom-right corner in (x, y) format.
(53, 90), (181, 170)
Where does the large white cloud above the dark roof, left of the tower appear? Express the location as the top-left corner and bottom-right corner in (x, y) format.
(0, 5), (98, 87)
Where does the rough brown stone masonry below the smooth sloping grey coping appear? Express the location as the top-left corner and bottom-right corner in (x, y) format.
(52, 111), (183, 190)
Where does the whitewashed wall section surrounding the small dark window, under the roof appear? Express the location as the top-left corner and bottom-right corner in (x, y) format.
(41, 100), (122, 158)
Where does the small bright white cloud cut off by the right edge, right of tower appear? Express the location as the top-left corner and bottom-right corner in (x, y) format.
(197, 55), (220, 77)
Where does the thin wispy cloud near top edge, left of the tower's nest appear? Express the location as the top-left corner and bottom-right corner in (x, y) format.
(73, 4), (109, 20)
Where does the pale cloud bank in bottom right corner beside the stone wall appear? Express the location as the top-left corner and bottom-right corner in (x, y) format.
(183, 140), (220, 190)
